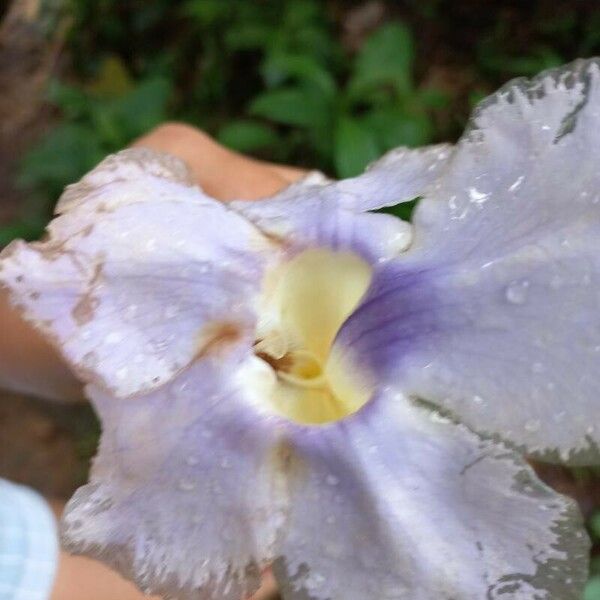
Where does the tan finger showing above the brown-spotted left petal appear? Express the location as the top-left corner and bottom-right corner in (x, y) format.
(133, 123), (303, 200)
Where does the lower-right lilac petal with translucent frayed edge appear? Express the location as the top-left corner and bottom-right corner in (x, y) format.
(275, 391), (589, 600)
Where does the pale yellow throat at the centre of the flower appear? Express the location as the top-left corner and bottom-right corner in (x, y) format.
(255, 249), (372, 424)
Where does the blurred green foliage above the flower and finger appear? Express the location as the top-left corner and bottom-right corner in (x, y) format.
(12, 0), (600, 226)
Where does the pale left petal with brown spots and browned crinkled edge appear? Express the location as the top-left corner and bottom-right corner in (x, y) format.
(0, 151), (276, 396)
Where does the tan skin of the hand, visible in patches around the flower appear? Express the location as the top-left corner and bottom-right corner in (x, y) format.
(0, 123), (306, 600)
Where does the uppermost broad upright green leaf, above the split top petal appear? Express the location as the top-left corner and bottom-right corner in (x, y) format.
(349, 22), (415, 96)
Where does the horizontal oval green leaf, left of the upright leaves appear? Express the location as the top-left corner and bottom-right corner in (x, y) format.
(249, 88), (331, 127)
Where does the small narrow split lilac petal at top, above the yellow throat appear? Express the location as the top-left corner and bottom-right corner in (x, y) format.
(231, 144), (451, 262)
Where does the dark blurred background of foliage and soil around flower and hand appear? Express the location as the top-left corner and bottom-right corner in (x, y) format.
(0, 0), (600, 600)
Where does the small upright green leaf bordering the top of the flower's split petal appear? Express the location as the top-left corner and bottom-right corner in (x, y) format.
(334, 117), (381, 177)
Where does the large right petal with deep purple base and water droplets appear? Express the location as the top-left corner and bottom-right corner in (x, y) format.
(340, 61), (600, 463)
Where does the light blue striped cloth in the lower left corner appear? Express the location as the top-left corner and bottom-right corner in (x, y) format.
(0, 479), (58, 600)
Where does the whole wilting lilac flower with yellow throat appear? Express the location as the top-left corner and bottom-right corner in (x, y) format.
(0, 61), (600, 600)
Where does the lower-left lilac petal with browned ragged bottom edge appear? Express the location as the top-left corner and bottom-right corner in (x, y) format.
(63, 360), (285, 600)
